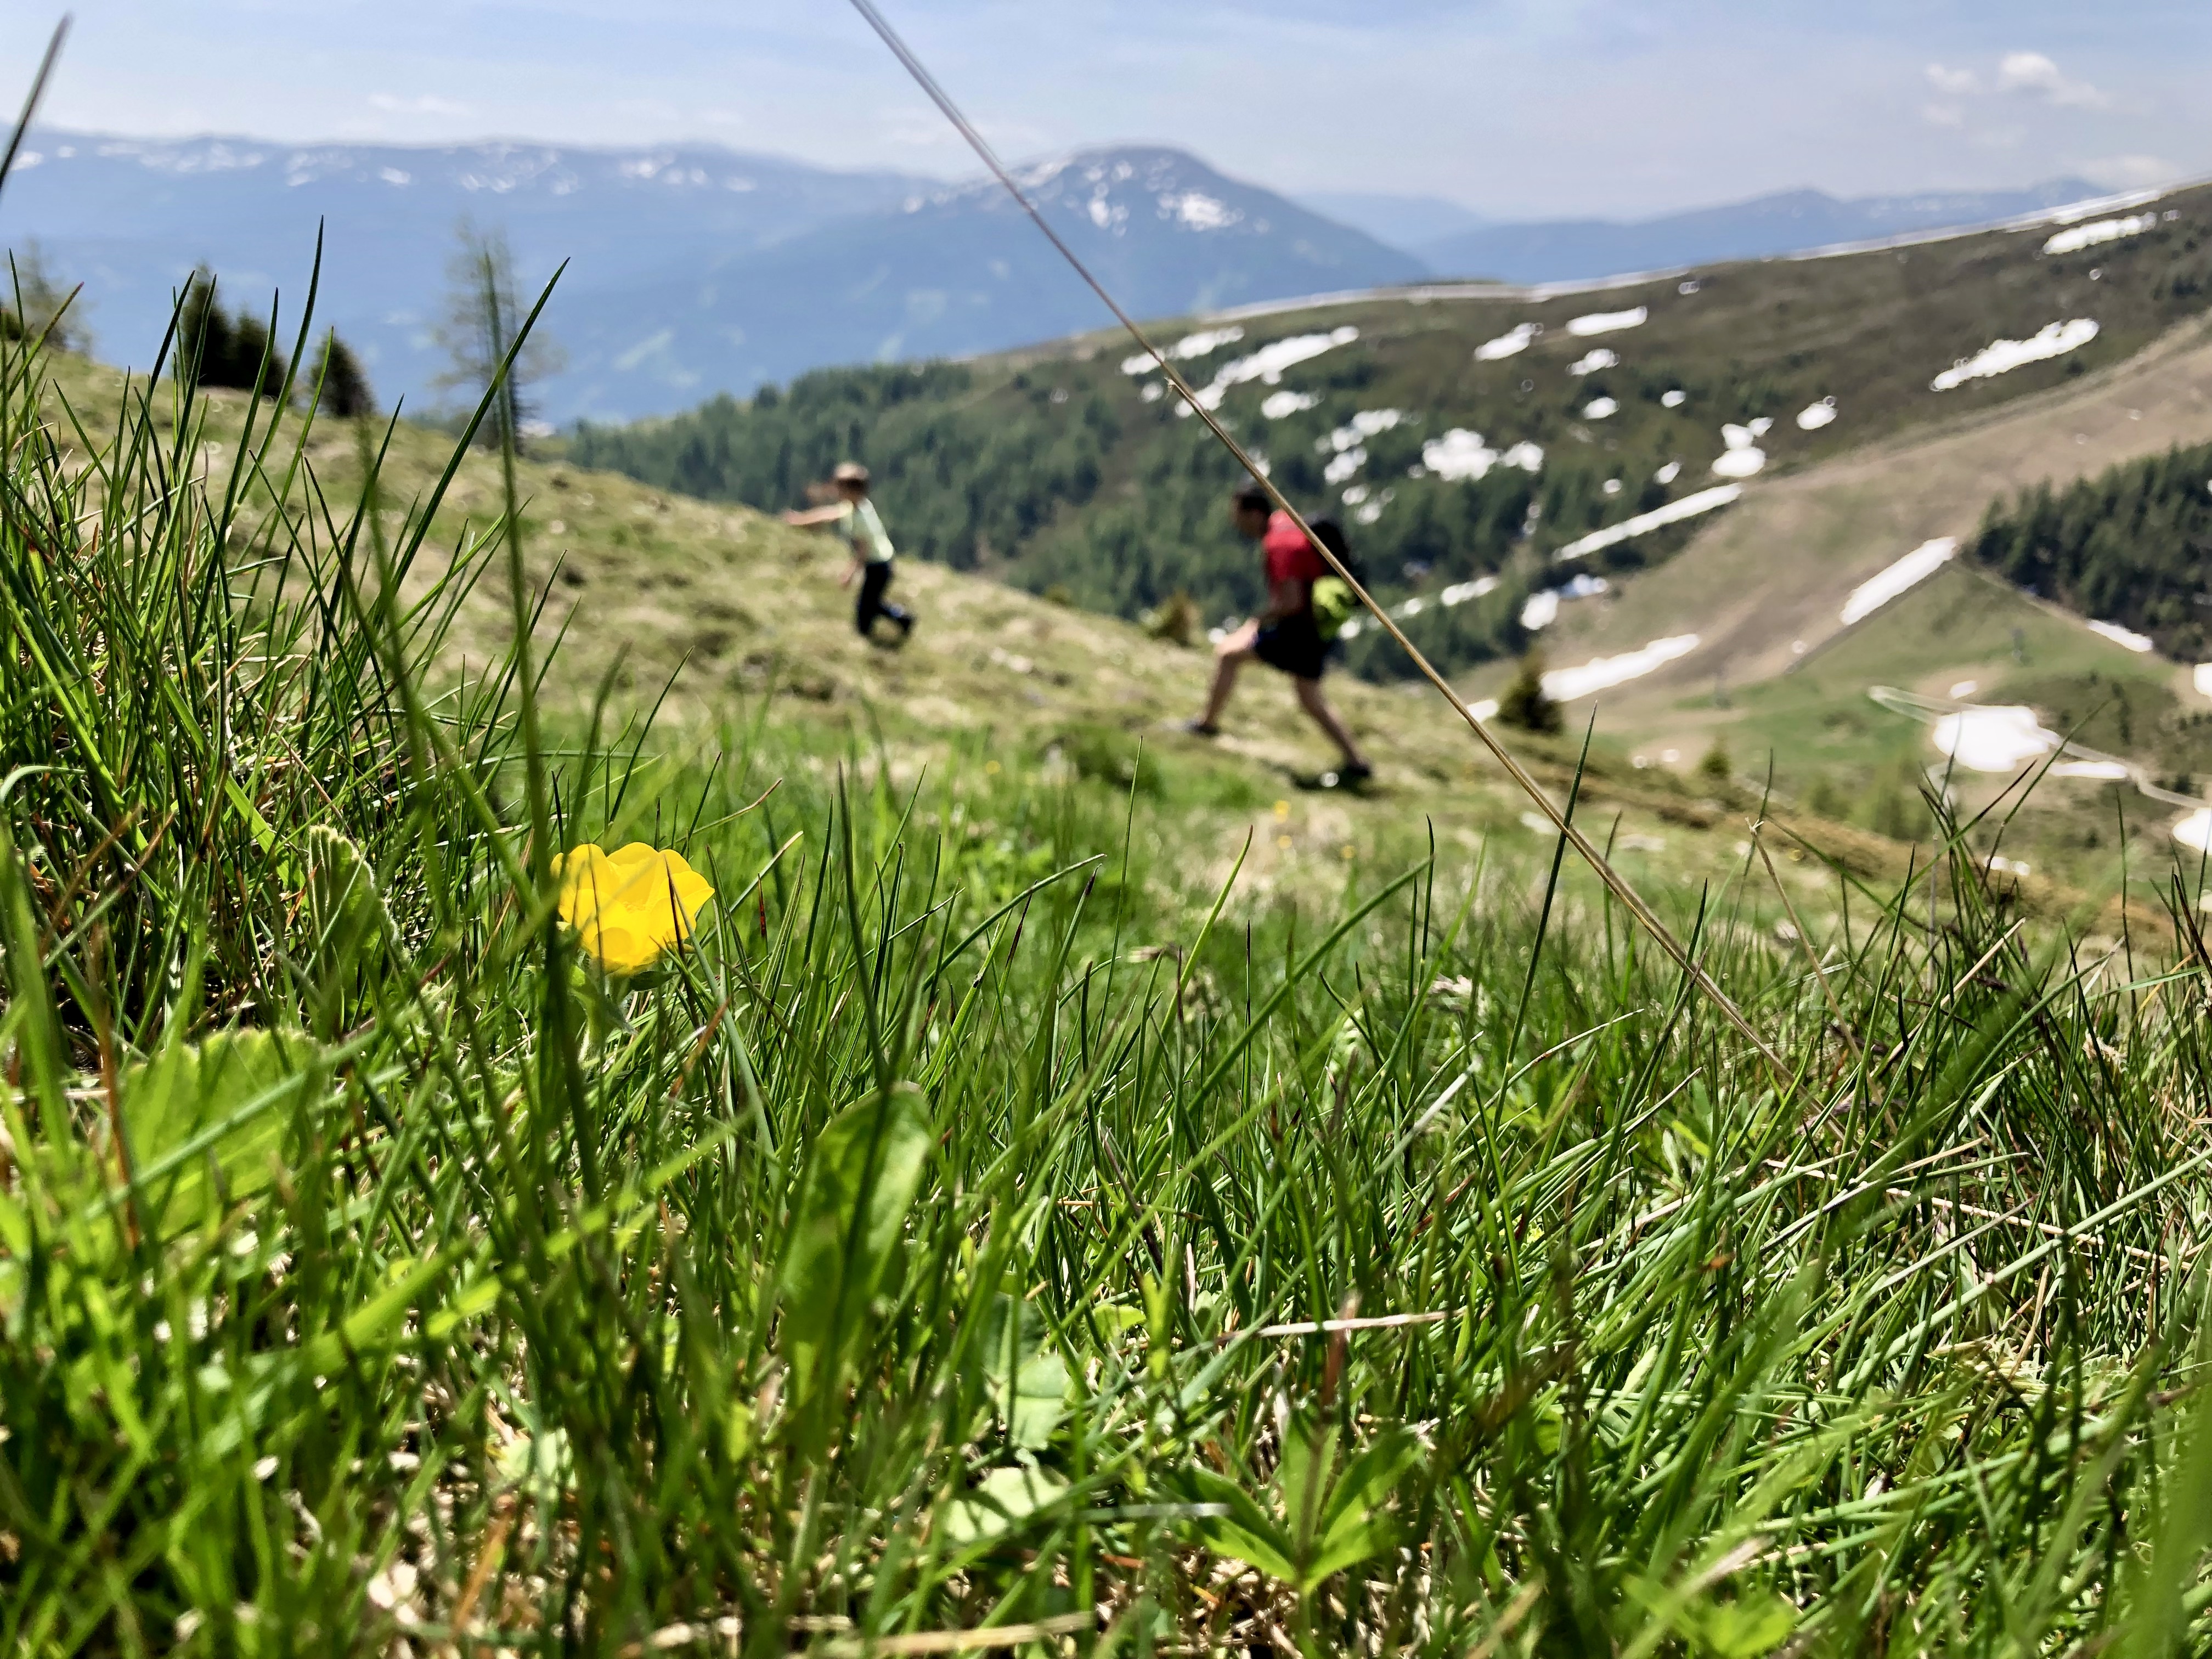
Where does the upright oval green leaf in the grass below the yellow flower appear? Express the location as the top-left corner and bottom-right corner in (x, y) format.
(781, 1084), (934, 1433)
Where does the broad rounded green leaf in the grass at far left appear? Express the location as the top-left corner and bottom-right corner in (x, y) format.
(122, 1031), (314, 1239)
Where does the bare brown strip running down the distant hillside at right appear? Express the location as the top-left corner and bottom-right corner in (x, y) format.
(1546, 321), (2212, 706)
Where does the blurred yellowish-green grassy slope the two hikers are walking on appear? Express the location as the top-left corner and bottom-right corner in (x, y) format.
(21, 345), (1907, 902)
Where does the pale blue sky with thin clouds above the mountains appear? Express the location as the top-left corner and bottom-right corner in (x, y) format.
(0, 0), (2212, 217)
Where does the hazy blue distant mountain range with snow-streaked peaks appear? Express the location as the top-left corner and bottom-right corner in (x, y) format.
(0, 131), (2141, 422)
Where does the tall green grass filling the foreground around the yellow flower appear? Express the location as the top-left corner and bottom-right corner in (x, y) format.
(0, 312), (2212, 1655)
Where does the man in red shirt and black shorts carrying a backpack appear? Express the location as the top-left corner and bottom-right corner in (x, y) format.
(1183, 484), (1374, 787)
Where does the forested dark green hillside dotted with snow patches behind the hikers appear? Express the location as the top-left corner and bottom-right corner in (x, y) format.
(573, 177), (2212, 677)
